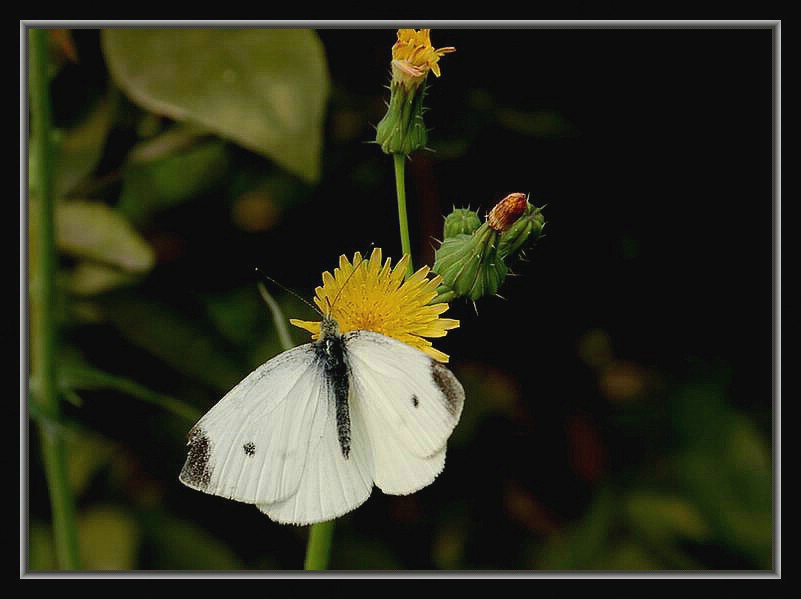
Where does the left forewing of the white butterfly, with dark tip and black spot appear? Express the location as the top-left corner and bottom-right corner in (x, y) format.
(180, 344), (335, 503)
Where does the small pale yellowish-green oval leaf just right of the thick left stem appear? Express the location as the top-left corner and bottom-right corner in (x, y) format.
(56, 200), (155, 273)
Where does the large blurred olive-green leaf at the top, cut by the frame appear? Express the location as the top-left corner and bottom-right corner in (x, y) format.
(102, 29), (329, 181)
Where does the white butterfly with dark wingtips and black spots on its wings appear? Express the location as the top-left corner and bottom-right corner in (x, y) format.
(175, 317), (464, 524)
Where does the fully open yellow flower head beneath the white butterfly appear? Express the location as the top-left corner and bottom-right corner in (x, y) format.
(289, 248), (459, 362)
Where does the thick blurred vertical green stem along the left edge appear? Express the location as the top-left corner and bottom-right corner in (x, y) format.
(28, 29), (80, 570)
